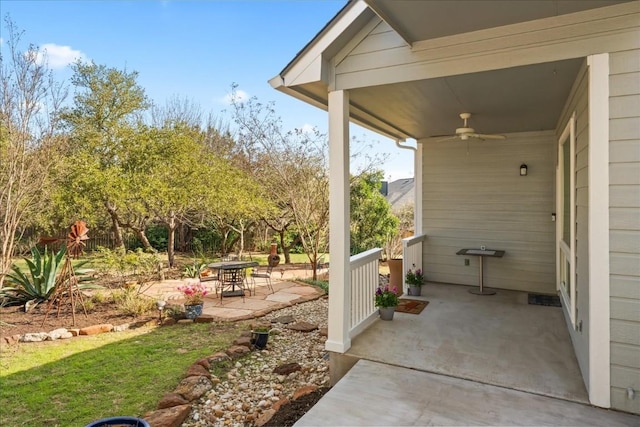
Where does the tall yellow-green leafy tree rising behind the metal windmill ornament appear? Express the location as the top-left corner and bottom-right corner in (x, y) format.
(59, 61), (149, 247)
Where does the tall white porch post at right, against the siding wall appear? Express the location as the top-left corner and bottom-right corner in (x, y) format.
(588, 53), (611, 408)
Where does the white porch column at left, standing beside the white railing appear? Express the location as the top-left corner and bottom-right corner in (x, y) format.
(325, 90), (351, 353)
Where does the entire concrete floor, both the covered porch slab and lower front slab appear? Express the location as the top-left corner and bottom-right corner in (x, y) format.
(296, 283), (640, 426)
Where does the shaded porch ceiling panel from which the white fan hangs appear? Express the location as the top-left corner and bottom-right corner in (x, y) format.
(350, 58), (584, 139)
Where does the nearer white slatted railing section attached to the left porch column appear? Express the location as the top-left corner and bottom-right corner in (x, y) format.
(349, 248), (382, 338)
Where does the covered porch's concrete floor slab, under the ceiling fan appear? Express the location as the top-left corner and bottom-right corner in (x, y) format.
(346, 283), (589, 403)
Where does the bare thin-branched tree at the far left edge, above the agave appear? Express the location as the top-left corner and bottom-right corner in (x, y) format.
(0, 17), (67, 288)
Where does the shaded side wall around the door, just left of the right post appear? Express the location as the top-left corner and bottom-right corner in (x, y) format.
(556, 61), (589, 392)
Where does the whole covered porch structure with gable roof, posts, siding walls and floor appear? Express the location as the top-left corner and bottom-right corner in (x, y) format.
(270, 0), (640, 418)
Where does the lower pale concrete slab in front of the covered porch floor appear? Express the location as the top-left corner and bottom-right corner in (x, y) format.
(295, 360), (640, 427)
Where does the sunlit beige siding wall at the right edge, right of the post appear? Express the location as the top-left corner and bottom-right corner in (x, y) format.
(609, 49), (640, 413)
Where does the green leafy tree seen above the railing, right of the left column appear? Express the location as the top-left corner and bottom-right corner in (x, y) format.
(350, 171), (399, 255)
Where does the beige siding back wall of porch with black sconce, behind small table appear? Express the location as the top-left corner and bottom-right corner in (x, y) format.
(420, 131), (556, 293)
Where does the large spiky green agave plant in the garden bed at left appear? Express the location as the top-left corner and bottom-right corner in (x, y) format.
(0, 246), (96, 305)
